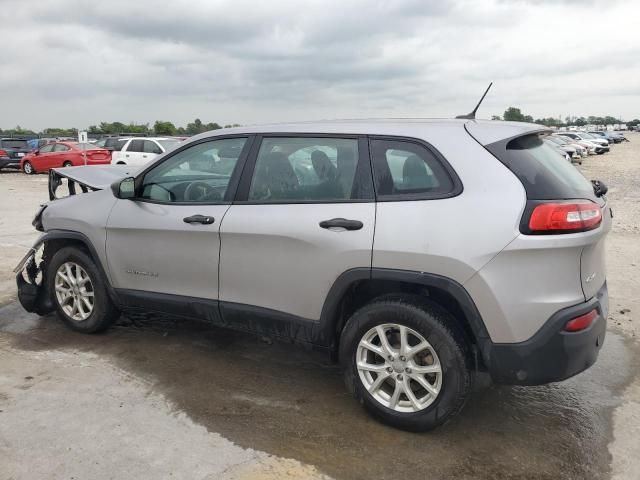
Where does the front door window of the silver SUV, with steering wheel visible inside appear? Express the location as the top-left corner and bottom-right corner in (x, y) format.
(140, 138), (247, 204)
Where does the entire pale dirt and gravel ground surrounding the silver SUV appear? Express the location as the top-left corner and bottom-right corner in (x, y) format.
(0, 134), (640, 480)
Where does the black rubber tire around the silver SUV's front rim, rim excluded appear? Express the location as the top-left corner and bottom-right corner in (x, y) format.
(47, 247), (120, 333)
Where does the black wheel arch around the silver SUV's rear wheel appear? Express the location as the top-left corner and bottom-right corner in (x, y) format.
(334, 279), (481, 368)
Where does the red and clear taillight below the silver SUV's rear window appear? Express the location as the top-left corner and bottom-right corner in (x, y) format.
(529, 201), (602, 233)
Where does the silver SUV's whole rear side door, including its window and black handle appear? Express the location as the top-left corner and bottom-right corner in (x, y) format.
(220, 135), (376, 328)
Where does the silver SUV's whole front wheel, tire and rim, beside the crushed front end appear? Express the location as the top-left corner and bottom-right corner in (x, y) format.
(47, 247), (119, 333)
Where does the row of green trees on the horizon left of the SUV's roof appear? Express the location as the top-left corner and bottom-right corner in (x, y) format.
(0, 118), (240, 137)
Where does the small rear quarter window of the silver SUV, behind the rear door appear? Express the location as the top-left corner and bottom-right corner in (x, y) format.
(370, 139), (454, 199)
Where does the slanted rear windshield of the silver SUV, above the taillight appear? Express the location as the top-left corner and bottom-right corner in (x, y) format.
(486, 134), (595, 200)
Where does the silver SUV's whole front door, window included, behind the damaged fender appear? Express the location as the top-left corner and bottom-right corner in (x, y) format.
(107, 137), (248, 300)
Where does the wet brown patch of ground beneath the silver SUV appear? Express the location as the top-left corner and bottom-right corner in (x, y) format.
(0, 306), (633, 479)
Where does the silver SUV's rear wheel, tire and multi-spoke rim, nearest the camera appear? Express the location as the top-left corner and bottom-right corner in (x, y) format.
(340, 299), (471, 431)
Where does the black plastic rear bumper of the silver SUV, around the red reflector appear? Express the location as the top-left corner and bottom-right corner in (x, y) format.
(488, 282), (609, 385)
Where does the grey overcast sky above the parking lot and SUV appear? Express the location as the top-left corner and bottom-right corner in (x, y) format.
(0, 0), (640, 129)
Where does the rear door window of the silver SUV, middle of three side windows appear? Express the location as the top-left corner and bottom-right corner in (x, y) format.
(248, 137), (358, 203)
